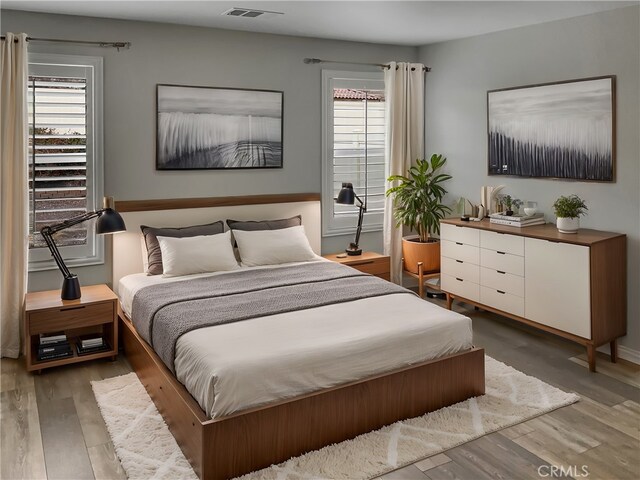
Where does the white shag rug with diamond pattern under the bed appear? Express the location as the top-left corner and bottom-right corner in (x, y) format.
(91, 356), (579, 480)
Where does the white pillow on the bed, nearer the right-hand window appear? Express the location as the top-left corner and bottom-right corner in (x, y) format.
(233, 225), (316, 267)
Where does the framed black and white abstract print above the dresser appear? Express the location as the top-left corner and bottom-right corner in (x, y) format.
(487, 77), (615, 181)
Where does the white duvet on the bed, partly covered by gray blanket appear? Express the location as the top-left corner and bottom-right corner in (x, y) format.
(118, 260), (472, 418)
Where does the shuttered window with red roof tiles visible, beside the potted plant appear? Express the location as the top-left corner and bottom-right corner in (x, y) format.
(322, 70), (385, 236)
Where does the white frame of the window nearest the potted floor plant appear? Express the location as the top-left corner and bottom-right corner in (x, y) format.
(322, 70), (386, 237)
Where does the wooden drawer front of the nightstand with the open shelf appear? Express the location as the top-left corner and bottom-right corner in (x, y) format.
(29, 302), (115, 335)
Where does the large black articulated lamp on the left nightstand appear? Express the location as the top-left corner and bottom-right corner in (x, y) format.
(40, 197), (126, 300)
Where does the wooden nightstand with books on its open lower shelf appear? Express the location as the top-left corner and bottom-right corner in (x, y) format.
(24, 285), (118, 372)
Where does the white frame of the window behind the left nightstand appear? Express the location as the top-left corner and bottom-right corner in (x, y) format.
(25, 53), (105, 272)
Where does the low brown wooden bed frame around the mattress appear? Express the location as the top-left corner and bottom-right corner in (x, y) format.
(114, 196), (485, 480)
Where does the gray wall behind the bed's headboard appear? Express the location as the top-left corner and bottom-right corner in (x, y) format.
(2, 10), (408, 291)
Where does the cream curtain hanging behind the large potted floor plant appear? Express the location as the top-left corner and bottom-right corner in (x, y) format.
(383, 62), (424, 284)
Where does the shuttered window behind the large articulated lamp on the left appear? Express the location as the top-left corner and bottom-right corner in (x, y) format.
(27, 54), (104, 271)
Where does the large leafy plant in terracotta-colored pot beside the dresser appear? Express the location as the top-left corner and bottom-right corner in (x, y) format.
(386, 153), (451, 274)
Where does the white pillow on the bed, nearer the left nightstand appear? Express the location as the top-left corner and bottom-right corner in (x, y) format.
(158, 231), (240, 277)
